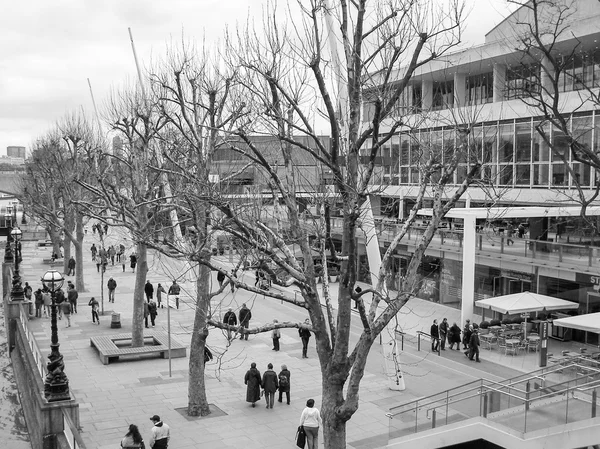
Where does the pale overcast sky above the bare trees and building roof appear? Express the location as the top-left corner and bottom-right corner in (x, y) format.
(0, 0), (514, 155)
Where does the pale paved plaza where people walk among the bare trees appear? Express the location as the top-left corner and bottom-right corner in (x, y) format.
(0, 229), (584, 449)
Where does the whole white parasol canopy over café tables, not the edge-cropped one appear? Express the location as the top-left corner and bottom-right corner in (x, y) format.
(475, 292), (579, 316)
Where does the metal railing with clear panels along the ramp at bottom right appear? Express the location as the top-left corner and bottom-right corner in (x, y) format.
(386, 356), (600, 439)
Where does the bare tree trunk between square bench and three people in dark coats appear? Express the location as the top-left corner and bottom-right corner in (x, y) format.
(188, 255), (210, 416)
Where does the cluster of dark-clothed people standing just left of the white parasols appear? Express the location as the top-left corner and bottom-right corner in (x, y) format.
(430, 318), (481, 362)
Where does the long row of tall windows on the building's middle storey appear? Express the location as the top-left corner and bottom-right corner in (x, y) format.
(372, 112), (600, 187)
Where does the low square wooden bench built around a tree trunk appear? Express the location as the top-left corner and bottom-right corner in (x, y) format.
(90, 331), (187, 365)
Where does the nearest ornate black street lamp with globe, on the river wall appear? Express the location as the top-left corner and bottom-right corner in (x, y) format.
(42, 270), (71, 402)
